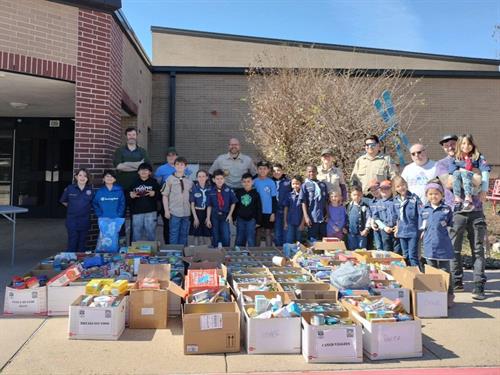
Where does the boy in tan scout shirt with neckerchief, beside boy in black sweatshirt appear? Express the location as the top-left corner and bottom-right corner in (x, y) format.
(161, 156), (193, 246)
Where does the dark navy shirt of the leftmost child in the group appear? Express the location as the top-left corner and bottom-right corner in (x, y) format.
(59, 184), (94, 228)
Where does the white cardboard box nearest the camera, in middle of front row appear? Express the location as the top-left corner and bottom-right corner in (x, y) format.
(302, 311), (363, 363)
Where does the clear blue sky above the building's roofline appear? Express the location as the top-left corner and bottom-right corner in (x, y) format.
(122, 0), (500, 59)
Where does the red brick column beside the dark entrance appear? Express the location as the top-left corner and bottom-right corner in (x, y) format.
(74, 9), (123, 242)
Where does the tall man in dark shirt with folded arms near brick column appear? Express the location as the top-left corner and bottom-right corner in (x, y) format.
(113, 128), (150, 191)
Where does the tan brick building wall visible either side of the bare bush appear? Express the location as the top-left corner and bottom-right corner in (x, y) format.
(150, 74), (500, 176)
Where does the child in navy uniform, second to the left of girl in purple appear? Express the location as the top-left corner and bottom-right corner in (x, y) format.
(283, 176), (304, 243)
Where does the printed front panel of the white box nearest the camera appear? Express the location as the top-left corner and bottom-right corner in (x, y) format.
(315, 327), (356, 357)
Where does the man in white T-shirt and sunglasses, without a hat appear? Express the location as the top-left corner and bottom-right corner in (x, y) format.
(401, 143), (436, 204)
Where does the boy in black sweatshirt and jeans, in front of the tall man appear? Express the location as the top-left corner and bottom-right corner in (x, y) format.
(129, 163), (160, 241)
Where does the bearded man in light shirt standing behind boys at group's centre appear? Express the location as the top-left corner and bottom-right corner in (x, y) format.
(208, 138), (257, 189)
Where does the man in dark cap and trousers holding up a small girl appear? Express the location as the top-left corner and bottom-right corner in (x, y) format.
(437, 135), (487, 300)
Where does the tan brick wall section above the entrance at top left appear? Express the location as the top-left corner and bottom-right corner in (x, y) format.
(0, 0), (78, 65)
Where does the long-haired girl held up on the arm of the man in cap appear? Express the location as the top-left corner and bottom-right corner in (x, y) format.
(449, 134), (491, 211)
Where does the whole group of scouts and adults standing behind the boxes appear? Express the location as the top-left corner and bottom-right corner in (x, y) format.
(61, 128), (490, 299)
